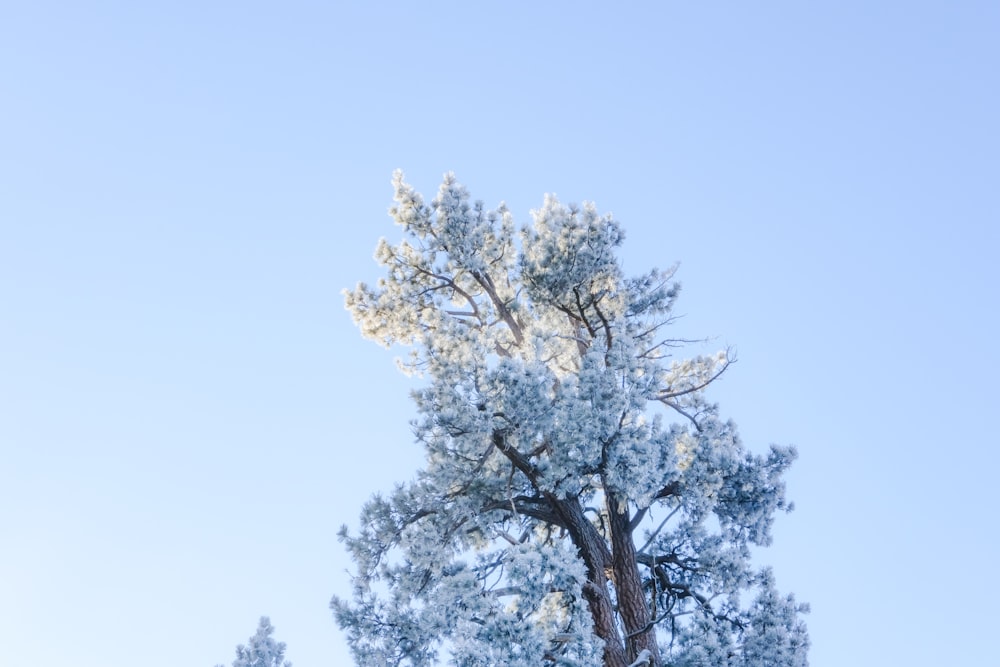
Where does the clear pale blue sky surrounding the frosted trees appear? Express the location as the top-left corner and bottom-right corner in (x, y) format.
(0, 0), (1000, 667)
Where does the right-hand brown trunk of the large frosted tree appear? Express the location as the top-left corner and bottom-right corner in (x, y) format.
(607, 496), (660, 667)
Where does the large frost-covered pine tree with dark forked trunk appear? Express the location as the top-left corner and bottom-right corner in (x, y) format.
(331, 172), (808, 667)
